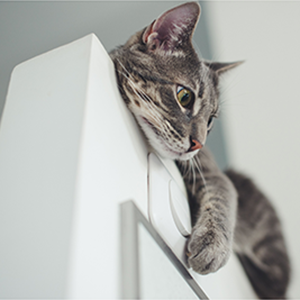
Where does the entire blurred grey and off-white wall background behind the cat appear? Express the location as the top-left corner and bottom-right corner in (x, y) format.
(0, 0), (300, 299)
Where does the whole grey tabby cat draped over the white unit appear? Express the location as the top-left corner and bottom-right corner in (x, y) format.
(111, 2), (290, 299)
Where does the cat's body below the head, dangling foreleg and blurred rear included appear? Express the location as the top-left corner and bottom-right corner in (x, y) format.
(177, 148), (290, 299)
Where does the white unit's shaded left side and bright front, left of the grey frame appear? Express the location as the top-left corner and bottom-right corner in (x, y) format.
(0, 35), (147, 299)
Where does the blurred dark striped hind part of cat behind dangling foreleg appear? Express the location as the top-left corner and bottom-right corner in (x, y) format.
(226, 171), (290, 299)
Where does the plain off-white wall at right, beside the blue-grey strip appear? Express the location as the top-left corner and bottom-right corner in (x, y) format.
(207, 1), (300, 299)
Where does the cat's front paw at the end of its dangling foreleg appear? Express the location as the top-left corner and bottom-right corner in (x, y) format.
(187, 225), (231, 274)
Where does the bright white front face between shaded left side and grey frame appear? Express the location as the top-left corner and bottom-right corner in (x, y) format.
(63, 35), (147, 299)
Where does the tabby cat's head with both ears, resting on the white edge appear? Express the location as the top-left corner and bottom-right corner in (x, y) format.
(111, 2), (239, 160)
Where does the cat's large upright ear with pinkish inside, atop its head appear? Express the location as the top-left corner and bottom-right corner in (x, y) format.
(142, 2), (200, 50)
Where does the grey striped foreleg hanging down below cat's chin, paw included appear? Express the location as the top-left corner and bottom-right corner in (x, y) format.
(178, 149), (237, 274)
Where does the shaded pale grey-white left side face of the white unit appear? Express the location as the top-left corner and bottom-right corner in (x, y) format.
(0, 31), (91, 298)
